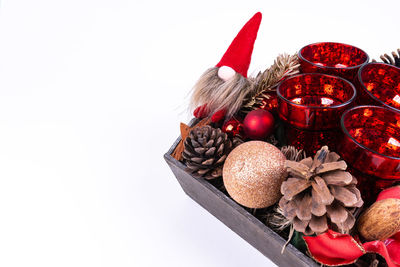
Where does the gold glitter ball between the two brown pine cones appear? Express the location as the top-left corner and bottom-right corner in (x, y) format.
(222, 141), (286, 208)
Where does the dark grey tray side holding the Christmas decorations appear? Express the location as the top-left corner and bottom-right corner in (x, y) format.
(164, 124), (319, 267)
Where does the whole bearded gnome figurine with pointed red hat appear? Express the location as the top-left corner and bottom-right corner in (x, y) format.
(190, 12), (262, 122)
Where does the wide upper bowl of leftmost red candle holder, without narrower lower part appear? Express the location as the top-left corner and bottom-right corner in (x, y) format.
(277, 73), (355, 131)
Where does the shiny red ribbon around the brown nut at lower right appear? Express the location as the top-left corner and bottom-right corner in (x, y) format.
(303, 186), (400, 267)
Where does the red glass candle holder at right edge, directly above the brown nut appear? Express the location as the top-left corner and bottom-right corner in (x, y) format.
(338, 106), (400, 179)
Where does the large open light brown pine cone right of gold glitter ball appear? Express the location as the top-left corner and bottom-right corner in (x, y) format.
(279, 146), (364, 235)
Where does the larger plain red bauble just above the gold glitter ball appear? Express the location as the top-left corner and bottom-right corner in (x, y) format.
(243, 109), (274, 140)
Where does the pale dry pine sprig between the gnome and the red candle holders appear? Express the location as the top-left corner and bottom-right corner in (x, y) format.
(243, 54), (300, 110)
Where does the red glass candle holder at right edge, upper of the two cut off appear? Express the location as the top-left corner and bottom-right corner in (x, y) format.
(356, 63), (400, 111)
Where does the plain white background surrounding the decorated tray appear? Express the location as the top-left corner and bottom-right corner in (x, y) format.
(0, 0), (400, 267)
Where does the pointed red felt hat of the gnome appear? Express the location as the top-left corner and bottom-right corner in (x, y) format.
(216, 12), (262, 78)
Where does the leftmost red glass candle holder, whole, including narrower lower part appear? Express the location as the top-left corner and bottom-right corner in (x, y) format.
(277, 73), (356, 153)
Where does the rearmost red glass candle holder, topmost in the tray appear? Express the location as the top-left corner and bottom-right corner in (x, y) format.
(298, 42), (369, 81)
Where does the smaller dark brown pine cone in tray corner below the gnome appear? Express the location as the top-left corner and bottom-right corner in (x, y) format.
(182, 125), (233, 179)
